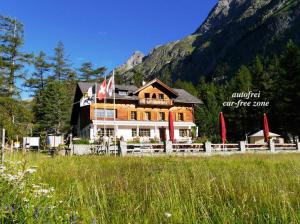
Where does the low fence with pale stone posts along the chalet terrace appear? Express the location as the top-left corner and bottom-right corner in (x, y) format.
(72, 141), (300, 156)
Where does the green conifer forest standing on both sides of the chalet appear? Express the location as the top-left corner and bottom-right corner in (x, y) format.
(0, 16), (300, 142)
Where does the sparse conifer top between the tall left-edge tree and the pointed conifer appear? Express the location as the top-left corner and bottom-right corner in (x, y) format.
(25, 51), (52, 91)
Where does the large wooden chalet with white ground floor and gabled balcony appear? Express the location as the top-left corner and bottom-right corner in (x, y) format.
(71, 79), (202, 141)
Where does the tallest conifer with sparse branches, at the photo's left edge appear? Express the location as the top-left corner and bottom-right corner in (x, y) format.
(0, 16), (32, 97)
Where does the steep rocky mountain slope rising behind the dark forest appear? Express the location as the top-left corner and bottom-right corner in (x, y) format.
(124, 0), (300, 81)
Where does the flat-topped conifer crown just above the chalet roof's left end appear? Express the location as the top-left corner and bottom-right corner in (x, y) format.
(79, 62), (106, 82)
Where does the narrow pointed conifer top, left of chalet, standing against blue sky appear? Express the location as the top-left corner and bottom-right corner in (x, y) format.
(52, 41), (71, 81)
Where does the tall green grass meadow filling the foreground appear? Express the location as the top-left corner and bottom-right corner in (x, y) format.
(0, 154), (300, 223)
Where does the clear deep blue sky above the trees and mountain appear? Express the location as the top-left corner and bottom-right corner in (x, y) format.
(0, 0), (217, 97)
